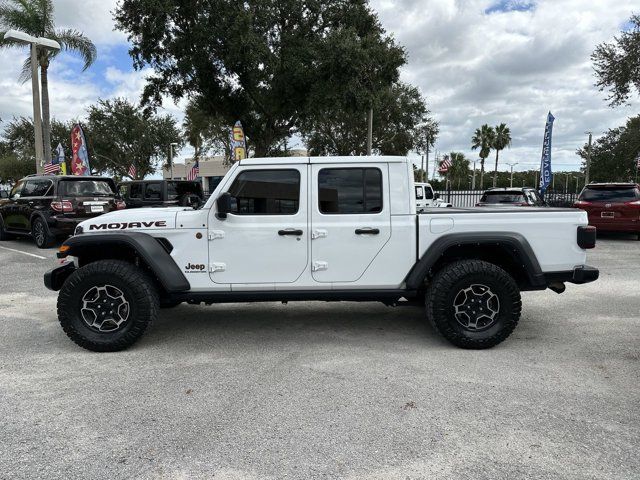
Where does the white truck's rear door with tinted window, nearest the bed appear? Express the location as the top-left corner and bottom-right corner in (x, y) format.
(311, 163), (391, 283)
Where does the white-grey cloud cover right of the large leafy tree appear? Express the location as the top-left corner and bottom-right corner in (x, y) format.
(372, 0), (637, 170)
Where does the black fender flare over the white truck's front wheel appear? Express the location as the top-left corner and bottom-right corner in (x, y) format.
(58, 232), (191, 293)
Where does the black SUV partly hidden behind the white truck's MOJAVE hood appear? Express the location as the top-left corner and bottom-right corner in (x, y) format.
(118, 180), (204, 208)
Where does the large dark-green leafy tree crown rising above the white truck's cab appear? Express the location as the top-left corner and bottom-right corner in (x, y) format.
(115, 0), (406, 156)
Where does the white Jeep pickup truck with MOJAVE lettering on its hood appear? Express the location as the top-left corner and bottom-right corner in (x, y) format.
(44, 157), (598, 351)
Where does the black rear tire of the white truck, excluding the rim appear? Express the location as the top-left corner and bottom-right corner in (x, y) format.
(425, 260), (522, 349)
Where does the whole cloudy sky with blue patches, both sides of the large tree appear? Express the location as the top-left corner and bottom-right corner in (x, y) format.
(0, 0), (640, 171)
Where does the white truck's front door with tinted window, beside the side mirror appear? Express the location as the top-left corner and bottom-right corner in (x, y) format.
(209, 164), (309, 289)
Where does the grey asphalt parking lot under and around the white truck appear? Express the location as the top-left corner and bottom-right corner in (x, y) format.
(0, 236), (640, 480)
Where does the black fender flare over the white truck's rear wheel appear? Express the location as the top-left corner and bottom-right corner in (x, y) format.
(405, 232), (547, 290)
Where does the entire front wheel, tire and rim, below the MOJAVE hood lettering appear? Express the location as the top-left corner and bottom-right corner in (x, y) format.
(58, 260), (159, 352)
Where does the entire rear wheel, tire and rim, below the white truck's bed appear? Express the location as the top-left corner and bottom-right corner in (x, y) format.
(426, 260), (522, 349)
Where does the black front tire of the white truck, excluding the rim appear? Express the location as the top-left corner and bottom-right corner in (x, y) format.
(58, 260), (160, 352)
